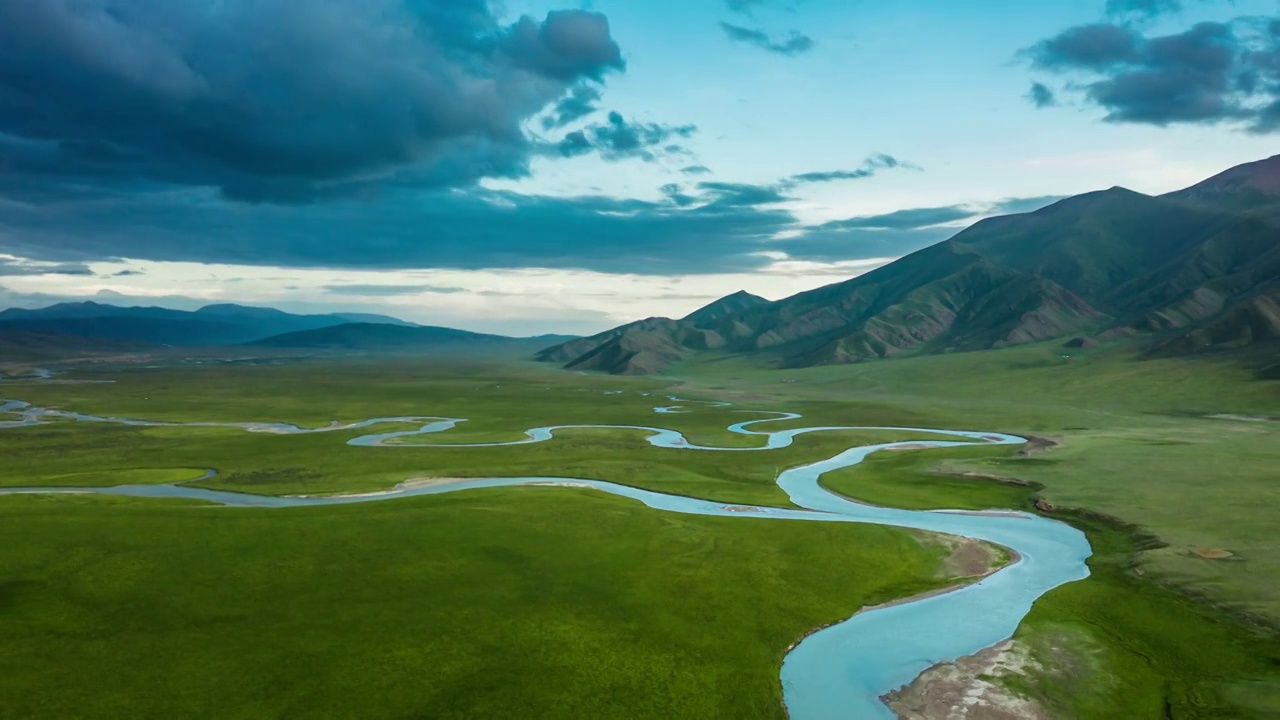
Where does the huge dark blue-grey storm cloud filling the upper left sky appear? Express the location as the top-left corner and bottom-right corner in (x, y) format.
(0, 0), (623, 201)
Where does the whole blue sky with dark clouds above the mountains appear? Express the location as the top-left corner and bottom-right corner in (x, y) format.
(0, 0), (1280, 336)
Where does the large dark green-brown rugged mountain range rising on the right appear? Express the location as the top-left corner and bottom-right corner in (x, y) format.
(540, 156), (1280, 374)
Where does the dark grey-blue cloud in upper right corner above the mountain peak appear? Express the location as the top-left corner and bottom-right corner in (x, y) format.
(1024, 18), (1280, 133)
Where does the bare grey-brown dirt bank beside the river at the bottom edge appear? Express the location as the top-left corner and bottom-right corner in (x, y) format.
(881, 641), (1047, 720)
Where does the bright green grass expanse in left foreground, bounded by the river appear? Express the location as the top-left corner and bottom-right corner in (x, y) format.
(0, 488), (946, 720)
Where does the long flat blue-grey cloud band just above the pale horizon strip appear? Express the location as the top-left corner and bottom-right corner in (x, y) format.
(0, 187), (796, 274)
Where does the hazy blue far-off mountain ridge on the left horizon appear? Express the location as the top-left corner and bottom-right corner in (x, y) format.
(0, 302), (411, 346)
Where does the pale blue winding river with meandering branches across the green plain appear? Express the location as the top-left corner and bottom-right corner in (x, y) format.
(0, 386), (1091, 720)
